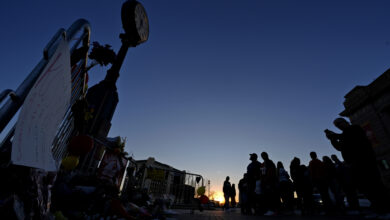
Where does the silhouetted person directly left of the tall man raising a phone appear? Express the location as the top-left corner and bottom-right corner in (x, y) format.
(331, 154), (359, 214)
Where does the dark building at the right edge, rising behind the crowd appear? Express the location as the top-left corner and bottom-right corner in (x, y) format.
(340, 69), (390, 190)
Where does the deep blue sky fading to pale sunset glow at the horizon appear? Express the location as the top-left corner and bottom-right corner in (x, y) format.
(0, 0), (390, 191)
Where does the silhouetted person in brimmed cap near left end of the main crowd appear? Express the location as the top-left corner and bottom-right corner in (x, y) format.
(246, 153), (261, 214)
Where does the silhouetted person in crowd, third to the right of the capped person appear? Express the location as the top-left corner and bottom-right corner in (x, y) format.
(290, 157), (313, 215)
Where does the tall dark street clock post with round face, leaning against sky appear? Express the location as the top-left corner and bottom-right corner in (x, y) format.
(86, 0), (149, 137)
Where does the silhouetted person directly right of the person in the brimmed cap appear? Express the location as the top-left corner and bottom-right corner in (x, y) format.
(261, 152), (280, 216)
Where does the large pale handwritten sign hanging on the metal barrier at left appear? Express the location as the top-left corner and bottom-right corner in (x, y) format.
(11, 40), (71, 171)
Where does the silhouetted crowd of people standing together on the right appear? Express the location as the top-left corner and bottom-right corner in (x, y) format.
(232, 118), (390, 219)
